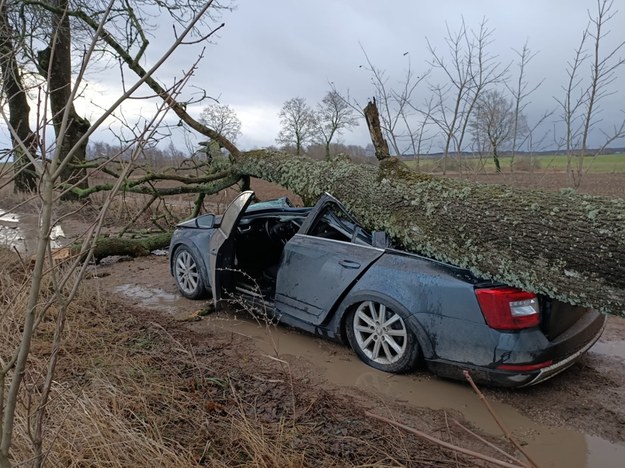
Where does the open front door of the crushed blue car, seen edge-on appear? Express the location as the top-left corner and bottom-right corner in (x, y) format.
(208, 190), (254, 307)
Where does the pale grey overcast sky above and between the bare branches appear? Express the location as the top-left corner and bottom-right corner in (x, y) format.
(7, 0), (625, 155)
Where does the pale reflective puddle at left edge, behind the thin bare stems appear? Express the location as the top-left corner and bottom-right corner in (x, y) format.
(0, 212), (65, 254)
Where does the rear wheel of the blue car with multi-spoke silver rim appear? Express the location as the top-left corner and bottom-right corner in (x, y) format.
(345, 300), (421, 373)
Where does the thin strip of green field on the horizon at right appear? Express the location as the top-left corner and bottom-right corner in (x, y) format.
(406, 153), (625, 174)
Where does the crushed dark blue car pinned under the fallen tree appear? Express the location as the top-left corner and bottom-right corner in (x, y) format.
(170, 191), (605, 387)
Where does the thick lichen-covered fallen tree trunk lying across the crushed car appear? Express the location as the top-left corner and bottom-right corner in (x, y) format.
(237, 151), (625, 316)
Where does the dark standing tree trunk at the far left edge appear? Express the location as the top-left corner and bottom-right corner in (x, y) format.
(0, 2), (37, 192)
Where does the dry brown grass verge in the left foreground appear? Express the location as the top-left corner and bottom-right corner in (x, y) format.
(0, 247), (478, 467)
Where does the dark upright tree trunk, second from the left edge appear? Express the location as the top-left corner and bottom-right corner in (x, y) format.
(44, 0), (91, 199)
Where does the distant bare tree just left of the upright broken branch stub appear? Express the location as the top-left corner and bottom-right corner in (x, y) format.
(316, 90), (358, 160)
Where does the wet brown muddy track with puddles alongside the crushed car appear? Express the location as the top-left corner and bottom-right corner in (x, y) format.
(96, 257), (625, 467)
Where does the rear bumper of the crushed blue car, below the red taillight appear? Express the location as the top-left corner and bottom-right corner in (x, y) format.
(427, 313), (606, 388)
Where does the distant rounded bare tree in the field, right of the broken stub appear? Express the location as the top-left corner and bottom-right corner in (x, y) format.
(469, 90), (527, 172)
